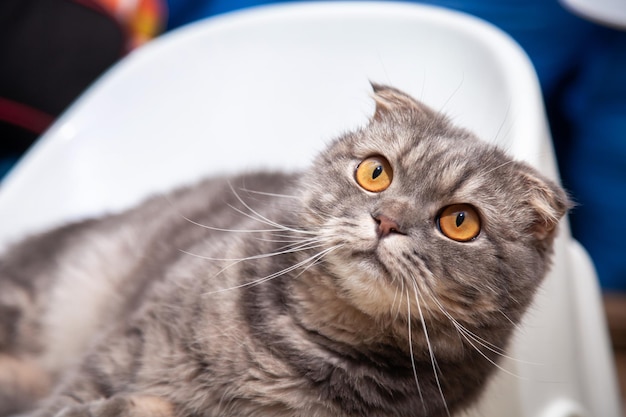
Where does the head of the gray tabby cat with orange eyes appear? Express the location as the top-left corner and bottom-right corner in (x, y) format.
(302, 85), (569, 326)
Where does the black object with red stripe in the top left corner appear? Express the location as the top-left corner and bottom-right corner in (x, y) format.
(0, 0), (127, 172)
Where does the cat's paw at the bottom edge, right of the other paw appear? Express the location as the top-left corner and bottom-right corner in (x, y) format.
(55, 396), (174, 417)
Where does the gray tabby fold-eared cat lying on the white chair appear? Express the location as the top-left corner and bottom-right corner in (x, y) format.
(0, 86), (569, 417)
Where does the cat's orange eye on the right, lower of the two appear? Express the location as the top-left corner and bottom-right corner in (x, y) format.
(437, 204), (480, 242)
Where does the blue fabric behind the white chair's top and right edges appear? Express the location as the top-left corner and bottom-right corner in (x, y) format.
(163, 0), (626, 291)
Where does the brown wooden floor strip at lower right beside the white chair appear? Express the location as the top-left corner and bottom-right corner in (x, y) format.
(604, 294), (626, 417)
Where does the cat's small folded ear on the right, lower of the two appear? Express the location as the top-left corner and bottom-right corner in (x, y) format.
(523, 172), (572, 240)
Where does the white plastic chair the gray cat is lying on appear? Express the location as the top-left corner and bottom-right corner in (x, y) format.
(0, 3), (621, 417)
